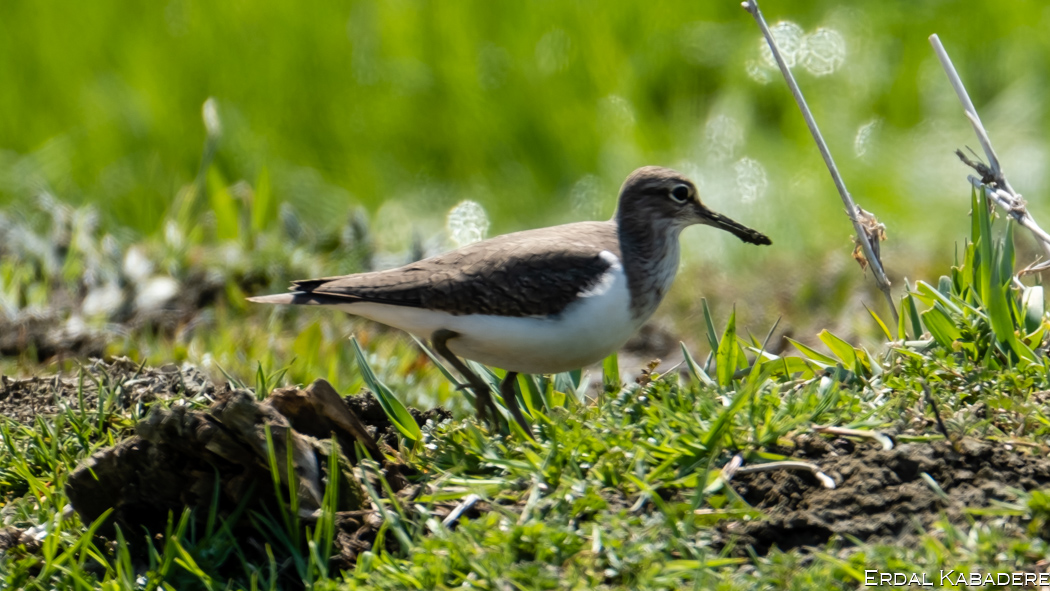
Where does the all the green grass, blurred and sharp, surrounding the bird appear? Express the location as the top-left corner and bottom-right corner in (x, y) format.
(0, 0), (1050, 590)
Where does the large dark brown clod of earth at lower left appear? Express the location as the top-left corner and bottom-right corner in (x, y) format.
(66, 382), (373, 531)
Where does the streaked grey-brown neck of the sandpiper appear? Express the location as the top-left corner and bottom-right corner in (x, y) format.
(613, 209), (684, 324)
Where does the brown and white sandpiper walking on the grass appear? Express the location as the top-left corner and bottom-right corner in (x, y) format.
(249, 166), (771, 434)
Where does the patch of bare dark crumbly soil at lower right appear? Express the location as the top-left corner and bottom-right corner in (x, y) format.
(718, 437), (1050, 554)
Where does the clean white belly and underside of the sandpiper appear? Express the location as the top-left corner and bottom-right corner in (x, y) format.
(335, 261), (644, 374)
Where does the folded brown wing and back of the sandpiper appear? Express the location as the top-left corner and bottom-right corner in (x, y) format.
(292, 221), (620, 317)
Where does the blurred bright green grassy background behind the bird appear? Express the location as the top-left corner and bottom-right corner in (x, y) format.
(0, 0), (1050, 392)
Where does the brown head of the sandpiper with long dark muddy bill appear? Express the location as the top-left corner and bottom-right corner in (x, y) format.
(616, 166), (773, 245)
